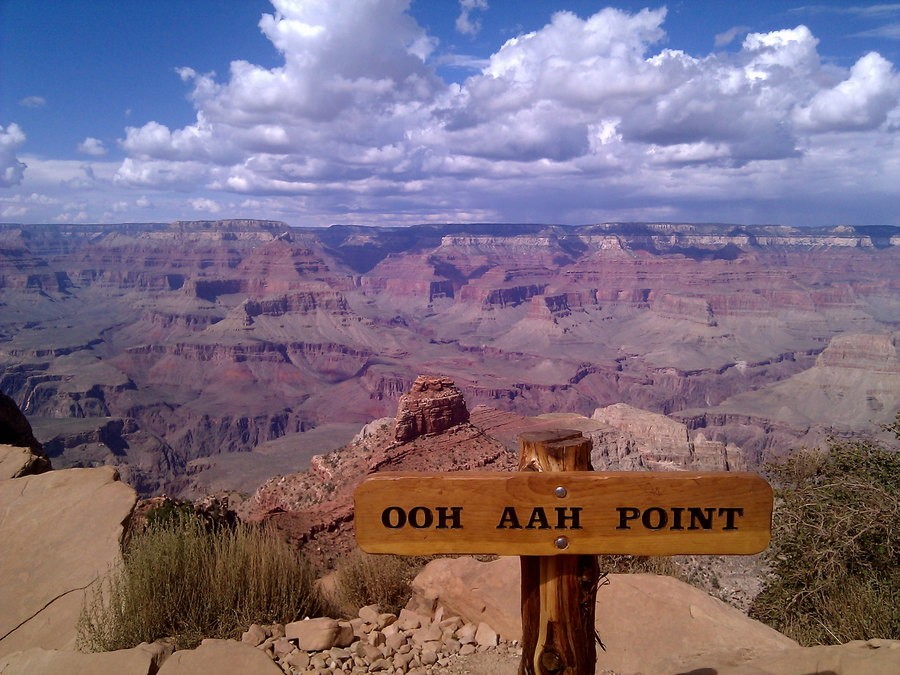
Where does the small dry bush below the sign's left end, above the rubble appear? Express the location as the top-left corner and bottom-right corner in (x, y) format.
(333, 550), (429, 616)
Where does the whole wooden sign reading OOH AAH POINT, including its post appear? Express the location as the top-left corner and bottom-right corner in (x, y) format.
(354, 430), (772, 675)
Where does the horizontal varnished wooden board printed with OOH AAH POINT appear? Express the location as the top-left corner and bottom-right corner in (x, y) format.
(355, 471), (772, 555)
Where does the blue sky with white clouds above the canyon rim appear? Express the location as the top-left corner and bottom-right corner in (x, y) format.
(0, 0), (900, 225)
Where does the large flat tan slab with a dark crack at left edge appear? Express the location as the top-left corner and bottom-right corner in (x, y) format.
(0, 467), (136, 655)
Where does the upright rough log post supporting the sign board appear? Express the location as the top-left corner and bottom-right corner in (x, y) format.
(519, 429), (600, 675)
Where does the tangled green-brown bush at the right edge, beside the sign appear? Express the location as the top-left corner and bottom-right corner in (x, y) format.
(750, 436), (900, 645)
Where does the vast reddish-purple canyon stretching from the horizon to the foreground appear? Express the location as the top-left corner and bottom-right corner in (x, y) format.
(0, 220), (900, 496)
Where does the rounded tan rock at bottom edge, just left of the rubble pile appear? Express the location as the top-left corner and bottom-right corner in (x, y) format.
(154, 640), (284, 675)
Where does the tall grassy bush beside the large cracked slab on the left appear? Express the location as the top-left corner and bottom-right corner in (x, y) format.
(78, 518), (319, 651)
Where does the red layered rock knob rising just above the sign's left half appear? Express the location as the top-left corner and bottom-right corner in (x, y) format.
(394, 375), (469, 443)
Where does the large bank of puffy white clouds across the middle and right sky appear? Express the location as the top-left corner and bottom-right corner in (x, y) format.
(102, 0), (900, 227)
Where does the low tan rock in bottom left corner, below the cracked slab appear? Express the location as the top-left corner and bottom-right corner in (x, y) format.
(0, 643), (172, 675)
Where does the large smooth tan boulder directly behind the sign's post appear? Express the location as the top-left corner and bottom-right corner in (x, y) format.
(411, 558), (797, 673)
